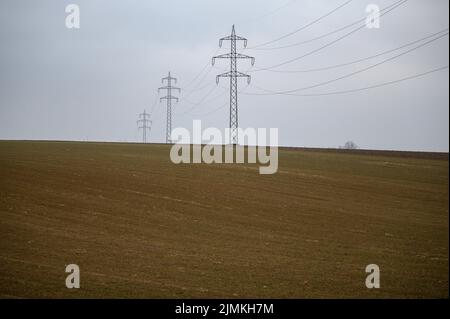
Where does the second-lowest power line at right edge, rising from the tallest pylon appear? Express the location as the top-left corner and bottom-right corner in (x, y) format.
(246, 32), (448, 95)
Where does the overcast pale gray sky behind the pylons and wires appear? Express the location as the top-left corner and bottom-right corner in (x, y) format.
(0, 0), (449, 151)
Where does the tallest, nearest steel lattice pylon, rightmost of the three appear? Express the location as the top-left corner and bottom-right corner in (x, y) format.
(212, 25), (255, 144)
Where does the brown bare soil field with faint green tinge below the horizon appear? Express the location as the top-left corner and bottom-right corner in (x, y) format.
(0, 141), (449, 298)
